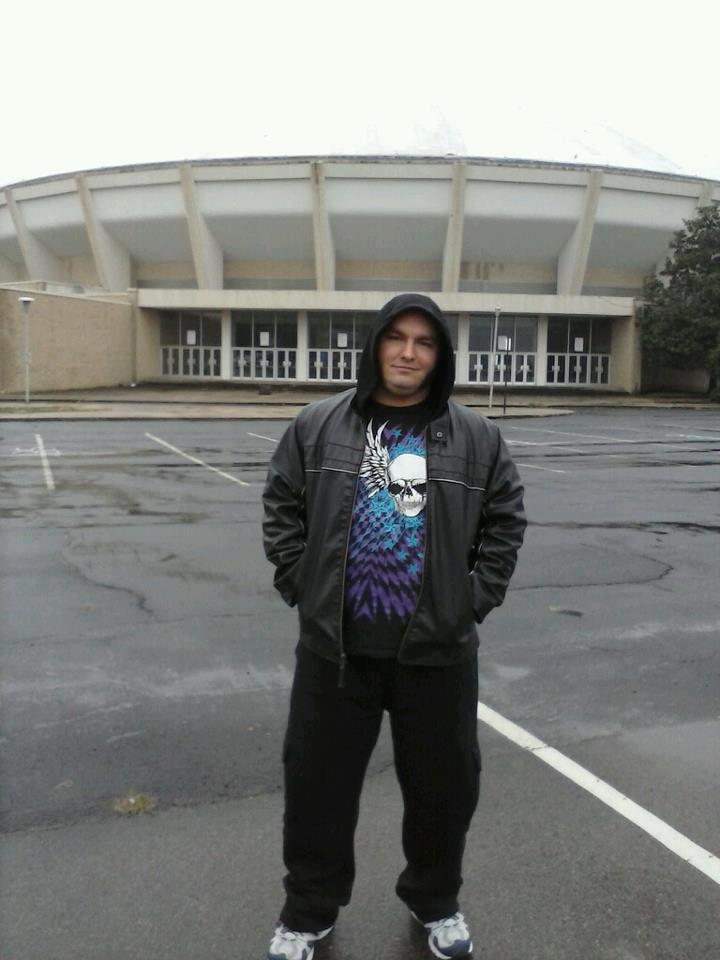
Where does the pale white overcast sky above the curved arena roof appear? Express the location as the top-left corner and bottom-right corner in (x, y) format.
(0, 0), (720, 185)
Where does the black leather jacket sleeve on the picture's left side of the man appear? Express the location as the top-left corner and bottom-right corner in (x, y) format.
(263, 418), (306, 607)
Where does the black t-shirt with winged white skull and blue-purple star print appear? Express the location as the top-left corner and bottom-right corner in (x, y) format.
(343, 403), (429, 657)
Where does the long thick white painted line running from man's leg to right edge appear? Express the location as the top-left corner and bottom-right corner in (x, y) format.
(477, 702), (720, 884)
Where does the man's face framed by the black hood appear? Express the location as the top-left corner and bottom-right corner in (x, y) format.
(374, 311), (438, 406)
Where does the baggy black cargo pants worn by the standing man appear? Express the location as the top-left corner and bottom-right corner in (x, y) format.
(280, 645), (480, 932)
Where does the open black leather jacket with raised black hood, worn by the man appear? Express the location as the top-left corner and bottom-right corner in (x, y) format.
(263, 295), (525, 666)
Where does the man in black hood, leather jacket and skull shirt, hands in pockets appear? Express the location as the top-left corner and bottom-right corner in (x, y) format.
(264, 294), (525, 960)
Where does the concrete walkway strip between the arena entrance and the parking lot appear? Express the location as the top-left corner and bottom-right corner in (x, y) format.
(0, 384), (720, 420)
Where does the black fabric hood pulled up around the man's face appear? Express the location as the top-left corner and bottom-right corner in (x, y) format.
(355, 293), (455, 417)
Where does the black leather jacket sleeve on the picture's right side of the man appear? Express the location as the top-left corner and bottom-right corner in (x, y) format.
(470, 431), (527, 623)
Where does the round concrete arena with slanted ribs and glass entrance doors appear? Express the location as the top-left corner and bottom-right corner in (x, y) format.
(0, 157), (720, 394)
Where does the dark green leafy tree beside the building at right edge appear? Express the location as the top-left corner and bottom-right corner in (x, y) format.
(640, 204), (720, 393)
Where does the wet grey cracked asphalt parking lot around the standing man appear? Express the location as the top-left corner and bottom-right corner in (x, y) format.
(0, 408), (720, 960)
